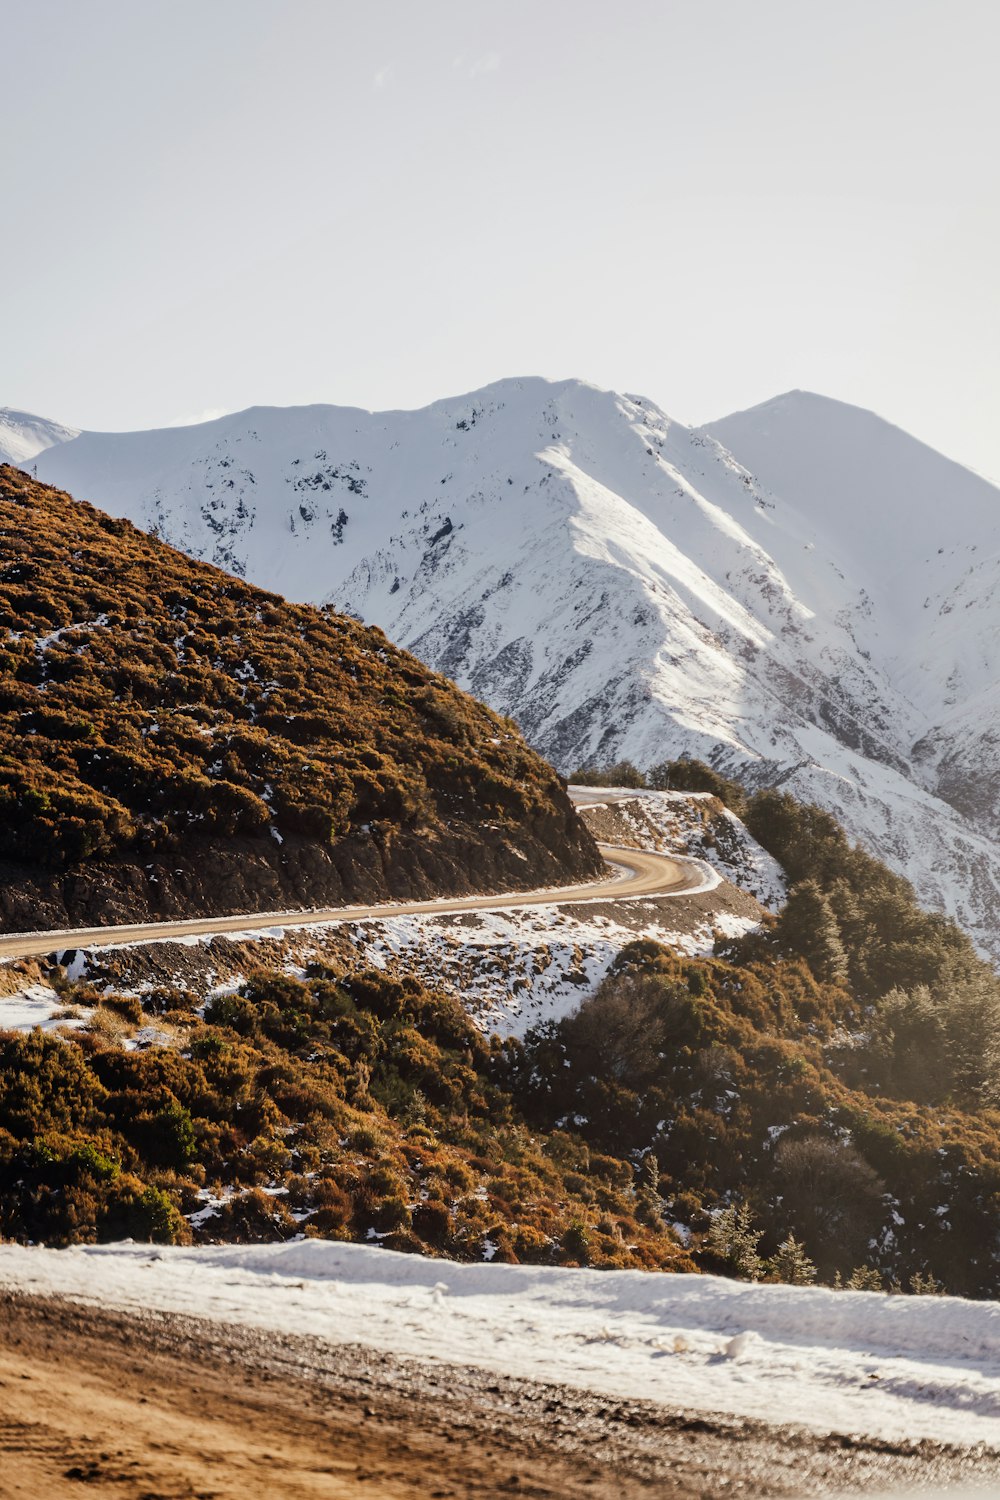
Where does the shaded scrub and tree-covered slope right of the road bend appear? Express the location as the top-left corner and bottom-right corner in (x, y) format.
(551, 761), (1000, 1296)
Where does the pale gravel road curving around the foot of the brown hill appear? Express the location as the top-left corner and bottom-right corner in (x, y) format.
(0, 845), (715, 959)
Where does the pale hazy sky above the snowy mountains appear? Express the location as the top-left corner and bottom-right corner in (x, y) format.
(7, 0), (1000, 480)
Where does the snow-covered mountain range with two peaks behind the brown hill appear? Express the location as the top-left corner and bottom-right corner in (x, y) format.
(25, 380), (1000, 956)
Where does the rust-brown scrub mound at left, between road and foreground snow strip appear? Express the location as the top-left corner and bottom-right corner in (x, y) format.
(0, 966), (693, 1269)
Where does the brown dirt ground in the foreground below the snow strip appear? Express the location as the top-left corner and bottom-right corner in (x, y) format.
(0, 1293), (1000, 1500)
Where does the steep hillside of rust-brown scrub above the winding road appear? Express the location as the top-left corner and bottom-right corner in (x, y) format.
(0, 467), (601, 930)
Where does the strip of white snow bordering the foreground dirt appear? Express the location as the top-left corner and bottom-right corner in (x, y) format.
(0, 1241), (1000, 1446)
